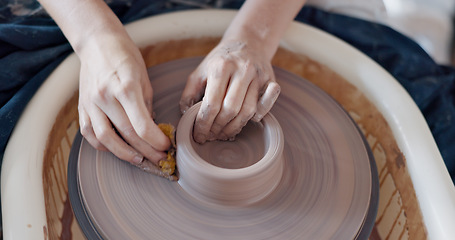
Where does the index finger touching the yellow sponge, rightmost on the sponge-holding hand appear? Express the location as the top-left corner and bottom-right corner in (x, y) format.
(116, 70), (171, 151)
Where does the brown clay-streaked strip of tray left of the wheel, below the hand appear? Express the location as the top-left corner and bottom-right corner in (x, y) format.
(43, 92), (79, 239)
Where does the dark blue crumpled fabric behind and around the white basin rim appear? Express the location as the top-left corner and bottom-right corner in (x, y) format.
(0, 0), (455, 226)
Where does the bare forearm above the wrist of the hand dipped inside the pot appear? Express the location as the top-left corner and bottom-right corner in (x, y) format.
(223, 0), (306, 59)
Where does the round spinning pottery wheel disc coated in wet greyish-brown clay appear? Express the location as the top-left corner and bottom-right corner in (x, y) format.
(68, 57), (378, 239)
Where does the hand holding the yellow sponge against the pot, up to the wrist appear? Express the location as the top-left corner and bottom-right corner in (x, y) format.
(78, 33), (170, 164)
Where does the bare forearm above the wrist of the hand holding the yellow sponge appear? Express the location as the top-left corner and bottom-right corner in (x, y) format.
(39, 0), (127, 55)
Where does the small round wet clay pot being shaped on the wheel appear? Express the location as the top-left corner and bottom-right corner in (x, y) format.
(177, 103), (284, 206)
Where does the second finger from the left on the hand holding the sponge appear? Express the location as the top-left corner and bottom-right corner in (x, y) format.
(90, 107), (144, 164)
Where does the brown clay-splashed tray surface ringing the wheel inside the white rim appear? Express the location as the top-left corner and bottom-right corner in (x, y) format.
(43, 38), (426, 239)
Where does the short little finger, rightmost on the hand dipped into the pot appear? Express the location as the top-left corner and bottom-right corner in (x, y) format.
(252, 80), (281, 122)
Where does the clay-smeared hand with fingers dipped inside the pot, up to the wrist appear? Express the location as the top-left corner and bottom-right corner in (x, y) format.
(180, 39), (280, 143)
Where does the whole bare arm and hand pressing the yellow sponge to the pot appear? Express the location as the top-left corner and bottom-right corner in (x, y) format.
(40, 0), (170, 164)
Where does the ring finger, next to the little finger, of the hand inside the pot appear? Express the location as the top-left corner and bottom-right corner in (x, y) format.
(217, 81), (259, 140)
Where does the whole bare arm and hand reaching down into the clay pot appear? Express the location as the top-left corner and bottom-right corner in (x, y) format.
(180, 0), (305, 143)
